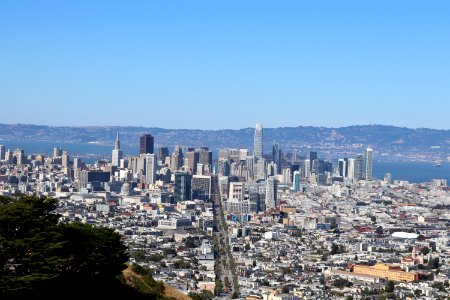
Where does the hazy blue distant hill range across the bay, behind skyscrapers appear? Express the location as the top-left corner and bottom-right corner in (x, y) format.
(0, 124), (450, 160)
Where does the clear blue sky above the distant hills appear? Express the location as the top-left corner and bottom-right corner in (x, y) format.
(0, 0), (450, 129)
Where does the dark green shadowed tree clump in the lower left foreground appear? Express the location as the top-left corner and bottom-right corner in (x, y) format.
(0, 195), (162, 299)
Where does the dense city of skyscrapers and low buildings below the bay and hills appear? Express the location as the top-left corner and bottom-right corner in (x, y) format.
(0, 124), (450, 300)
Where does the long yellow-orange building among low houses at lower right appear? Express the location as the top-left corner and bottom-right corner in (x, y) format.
(353, 263), (419, 282)
